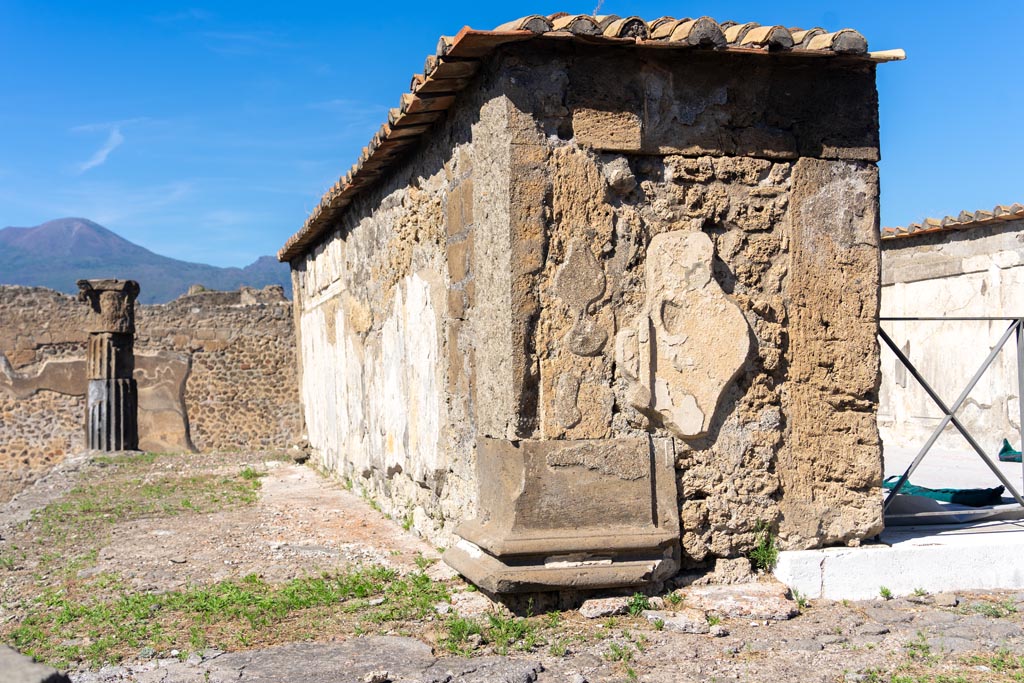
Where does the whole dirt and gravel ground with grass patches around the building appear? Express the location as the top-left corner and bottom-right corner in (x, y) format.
(6, 454), (1024, 683)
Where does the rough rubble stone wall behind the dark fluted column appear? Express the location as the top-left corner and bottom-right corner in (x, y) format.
(0, 284), (302, 500)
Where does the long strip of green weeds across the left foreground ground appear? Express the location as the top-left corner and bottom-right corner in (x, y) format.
(6, 565), (449, 666)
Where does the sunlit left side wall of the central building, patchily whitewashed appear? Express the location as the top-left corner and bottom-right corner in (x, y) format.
(292, 76), (489, 538)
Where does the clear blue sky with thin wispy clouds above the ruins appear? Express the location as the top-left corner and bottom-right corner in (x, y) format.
(0, 0), (1024, 265)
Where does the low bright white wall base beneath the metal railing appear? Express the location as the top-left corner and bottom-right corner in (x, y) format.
(774, 521), (1024, 600)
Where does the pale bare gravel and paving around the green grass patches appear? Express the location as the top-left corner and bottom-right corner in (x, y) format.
(0, 454), (1024, 683)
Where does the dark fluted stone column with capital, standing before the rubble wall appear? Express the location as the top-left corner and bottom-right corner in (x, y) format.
(78, 280), (138, 451)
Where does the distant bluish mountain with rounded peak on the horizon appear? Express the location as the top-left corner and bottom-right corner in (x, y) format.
(0, 218), (292, 303)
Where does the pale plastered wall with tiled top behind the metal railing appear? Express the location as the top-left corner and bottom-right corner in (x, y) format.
(879, 204), (1024, 455)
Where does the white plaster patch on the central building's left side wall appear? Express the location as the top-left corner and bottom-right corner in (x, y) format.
(299, 273), (441, 480)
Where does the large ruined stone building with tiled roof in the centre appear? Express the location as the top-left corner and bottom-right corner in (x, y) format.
(279, 14), (901, 592)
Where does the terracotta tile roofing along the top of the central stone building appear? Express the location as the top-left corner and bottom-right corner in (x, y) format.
(278, 12), (905, 261)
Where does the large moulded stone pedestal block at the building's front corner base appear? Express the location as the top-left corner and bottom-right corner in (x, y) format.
(444, 437), (679, 593)
